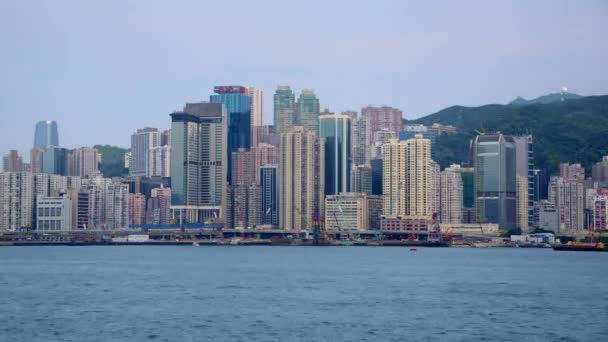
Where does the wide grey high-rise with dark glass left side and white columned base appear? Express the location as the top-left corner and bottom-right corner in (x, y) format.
(171, 102), (227, 223)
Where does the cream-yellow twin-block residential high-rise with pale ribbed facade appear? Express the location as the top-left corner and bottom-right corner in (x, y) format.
(382, 135), (432, 221)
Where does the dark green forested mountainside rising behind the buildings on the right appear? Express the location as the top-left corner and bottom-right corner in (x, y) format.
(408, 95), (608, 174)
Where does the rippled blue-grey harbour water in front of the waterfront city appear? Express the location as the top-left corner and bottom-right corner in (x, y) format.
(0, 246), (608, 342)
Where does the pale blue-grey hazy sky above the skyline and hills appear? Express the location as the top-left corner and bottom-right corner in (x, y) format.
(0, 0), (608, 160)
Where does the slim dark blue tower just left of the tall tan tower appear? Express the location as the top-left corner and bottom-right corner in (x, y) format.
(259, 164), (279, 226)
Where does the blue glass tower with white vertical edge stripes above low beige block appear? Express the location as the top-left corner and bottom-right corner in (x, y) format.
(319, 114), (351, 195)
